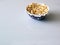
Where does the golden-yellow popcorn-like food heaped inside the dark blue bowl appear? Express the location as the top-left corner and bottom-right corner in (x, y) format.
(26, 3), (48, 15)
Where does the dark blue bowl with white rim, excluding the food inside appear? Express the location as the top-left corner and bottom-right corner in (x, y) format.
(26, 3), (49, 20)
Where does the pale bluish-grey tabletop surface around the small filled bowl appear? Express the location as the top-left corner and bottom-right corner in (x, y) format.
(0, 0), (60, 45)
